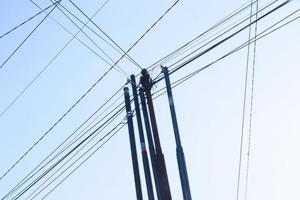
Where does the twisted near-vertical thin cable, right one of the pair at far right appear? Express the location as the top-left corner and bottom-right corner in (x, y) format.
(245, 2), (258, 200)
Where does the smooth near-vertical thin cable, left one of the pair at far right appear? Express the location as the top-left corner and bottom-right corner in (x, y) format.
(236, 0), (253, 200)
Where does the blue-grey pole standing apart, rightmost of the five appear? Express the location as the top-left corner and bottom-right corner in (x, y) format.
(162, 67), (192, 200)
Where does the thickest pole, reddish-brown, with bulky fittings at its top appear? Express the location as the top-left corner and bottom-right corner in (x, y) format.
(141, 69), (172, 200)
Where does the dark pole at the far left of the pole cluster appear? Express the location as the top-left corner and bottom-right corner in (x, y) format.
(124, 87), (143, 200)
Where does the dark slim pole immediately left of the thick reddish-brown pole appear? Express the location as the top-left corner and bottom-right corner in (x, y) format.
(139, 88), (162, 200)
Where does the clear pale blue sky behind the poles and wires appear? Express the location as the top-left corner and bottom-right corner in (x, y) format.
(0, 0), (300, 200)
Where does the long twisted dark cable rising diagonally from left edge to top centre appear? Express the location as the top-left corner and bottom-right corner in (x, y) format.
(0, 0), (179, 188)
